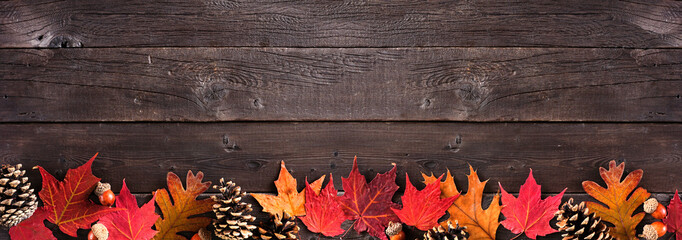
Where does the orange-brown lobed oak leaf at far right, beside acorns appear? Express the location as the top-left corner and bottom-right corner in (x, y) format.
(583, 161), (651, 240)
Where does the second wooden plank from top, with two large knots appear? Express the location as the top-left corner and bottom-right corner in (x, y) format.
(0, 48), (682, 122)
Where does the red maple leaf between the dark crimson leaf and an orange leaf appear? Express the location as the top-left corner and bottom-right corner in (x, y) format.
(391, 173), (459, 231)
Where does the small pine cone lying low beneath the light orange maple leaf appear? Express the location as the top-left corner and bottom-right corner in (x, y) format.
(256, 213), (299, 240)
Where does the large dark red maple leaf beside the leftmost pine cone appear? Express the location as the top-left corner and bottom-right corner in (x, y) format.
(37, 154), (121, 237)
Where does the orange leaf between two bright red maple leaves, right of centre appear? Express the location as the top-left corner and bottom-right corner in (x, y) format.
(422, 165), (502, 240)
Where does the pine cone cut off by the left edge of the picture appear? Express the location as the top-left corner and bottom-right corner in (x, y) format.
(0, 164), (38, 228)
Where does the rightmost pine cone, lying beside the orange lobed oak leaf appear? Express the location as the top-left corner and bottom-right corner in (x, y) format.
(556, 198), (614, 240)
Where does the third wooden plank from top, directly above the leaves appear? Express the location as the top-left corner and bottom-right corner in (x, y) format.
(0, 122), (682, 193)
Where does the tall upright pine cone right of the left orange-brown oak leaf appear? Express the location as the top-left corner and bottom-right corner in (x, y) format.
(211, 178), (256, 240)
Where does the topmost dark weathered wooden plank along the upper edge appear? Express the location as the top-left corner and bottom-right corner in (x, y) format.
(0, 0), (682, 48)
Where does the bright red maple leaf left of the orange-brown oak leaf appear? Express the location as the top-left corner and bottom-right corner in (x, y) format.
(99, 179), (159, 240)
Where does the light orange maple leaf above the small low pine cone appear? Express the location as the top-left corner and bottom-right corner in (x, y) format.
(251, 161), (325, 216)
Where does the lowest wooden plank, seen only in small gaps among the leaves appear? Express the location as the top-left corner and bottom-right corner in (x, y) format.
(0, 193), (672, 240)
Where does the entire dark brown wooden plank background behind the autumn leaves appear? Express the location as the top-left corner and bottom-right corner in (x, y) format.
(0, 0), (682, 240)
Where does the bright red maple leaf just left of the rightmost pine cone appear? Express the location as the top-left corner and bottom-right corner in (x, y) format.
(500, 169), (566, 239)
